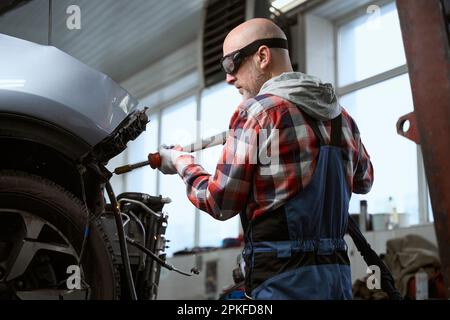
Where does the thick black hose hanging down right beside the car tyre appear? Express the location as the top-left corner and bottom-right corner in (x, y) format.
(106, 181), (137, 300)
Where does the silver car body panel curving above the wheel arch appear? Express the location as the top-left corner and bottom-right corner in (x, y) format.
(0, 34), (138, 146)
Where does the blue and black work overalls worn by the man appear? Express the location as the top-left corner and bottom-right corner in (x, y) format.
(241, 115), (352, 299)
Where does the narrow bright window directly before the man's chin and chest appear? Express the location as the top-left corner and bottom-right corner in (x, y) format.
(199, 82), (242, 246)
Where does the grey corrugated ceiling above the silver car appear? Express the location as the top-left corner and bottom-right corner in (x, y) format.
(0, 0), (204, 82)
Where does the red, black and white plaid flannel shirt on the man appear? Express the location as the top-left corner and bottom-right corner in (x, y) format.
(177, 95), (373, 220)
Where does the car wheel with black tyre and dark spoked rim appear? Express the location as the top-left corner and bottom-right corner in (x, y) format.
(0, 170), (120, 300)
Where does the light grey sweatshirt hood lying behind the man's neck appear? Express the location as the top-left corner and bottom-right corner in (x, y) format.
(258, 72), (341, 121)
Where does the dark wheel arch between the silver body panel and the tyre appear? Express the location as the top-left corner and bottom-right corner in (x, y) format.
(0, 113), (103, 213)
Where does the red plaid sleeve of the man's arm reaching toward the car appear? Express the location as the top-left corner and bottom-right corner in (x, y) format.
(178, 109), (257, 220)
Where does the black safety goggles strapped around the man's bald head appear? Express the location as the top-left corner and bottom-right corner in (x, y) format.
(220, 38), (288, 75)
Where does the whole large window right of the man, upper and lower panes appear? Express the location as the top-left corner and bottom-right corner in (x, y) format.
(336, 2), (428, 224)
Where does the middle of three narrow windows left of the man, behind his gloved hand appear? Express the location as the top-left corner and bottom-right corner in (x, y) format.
(158, 97), (197, 255)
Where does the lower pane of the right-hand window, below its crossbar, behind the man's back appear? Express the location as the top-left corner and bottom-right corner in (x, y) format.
(341, 74), (419, 224)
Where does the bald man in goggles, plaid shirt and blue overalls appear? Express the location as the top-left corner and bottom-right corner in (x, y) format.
(156, 19), (373, 299)
